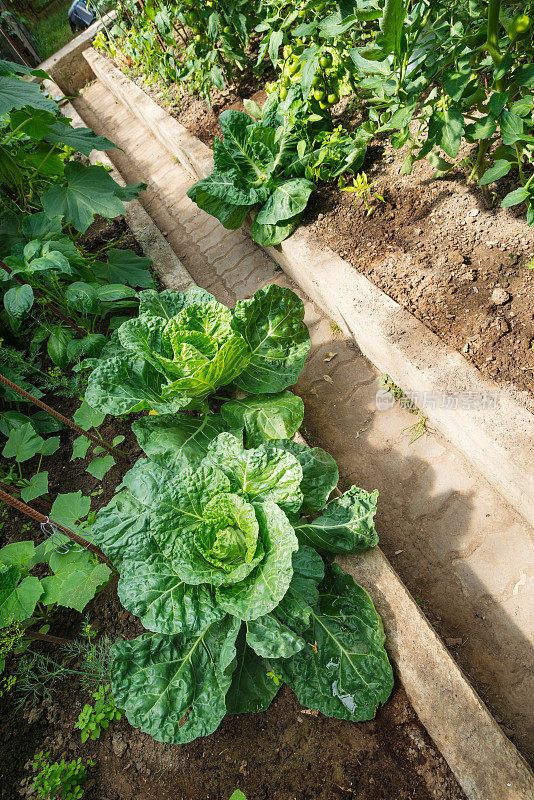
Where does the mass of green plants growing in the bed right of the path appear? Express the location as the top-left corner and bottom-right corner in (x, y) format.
(95, 0), (534, 245)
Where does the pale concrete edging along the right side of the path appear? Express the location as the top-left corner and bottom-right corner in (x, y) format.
(83, 49), (534, 524)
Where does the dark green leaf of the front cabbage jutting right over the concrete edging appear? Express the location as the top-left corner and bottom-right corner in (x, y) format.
(295, 486), (378, 553)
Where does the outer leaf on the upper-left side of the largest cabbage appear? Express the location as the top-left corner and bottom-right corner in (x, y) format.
(91, 458), (170, 570)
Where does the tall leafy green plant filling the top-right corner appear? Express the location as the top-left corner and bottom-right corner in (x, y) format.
(351, 0), (534, 217)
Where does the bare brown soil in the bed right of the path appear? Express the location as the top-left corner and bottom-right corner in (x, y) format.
(122, 62), (534, 410)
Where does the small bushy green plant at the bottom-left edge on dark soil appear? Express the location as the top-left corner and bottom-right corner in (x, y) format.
(28, 750), (95, 800)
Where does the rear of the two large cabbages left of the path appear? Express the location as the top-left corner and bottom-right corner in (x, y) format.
(84, 284), (310, 414)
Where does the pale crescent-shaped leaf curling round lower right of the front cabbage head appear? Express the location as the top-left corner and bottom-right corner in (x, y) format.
(215, 500), (298, 621)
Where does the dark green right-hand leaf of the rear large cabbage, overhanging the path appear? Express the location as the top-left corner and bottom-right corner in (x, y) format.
(232, 284), (311, 394)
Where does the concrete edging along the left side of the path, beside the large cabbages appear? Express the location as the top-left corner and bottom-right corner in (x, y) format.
(49, 75), (534, 800)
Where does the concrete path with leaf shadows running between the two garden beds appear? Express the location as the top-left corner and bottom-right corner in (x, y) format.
(74, 82), (534, 759)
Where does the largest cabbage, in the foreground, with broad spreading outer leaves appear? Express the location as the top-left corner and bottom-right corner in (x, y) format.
(93, 422), (393, 743)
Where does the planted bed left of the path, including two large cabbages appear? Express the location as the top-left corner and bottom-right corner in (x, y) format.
(0, 63), (393, 756)
